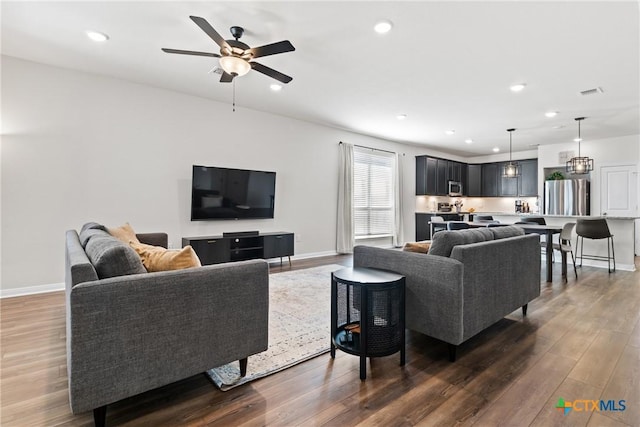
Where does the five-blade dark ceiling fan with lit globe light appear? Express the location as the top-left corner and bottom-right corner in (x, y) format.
(162, 16), (296, 83)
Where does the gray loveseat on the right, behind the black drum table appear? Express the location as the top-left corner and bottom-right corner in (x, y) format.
(353, 226), (540, 361)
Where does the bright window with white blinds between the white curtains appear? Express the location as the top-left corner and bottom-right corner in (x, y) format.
(353, 147), (395, 238)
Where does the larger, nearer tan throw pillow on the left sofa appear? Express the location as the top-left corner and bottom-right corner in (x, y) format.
(129, 242), (202, 273)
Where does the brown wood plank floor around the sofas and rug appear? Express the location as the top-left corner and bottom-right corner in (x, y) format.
(0, 257), (640, 427)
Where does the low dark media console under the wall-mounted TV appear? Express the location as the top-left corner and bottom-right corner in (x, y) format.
(182, 231), (294, 265)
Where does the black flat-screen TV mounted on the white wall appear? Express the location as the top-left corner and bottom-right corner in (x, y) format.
(191, 165), (276, 221)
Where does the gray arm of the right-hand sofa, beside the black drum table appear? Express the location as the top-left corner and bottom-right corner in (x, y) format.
(353, 246), (464, 345)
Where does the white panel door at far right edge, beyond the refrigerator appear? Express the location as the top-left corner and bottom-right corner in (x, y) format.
(600, 165), (638, 217)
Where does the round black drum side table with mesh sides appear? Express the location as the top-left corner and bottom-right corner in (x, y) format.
(331, 267), (405, 380)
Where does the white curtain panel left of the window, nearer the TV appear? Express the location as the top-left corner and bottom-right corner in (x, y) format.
(336, 142), (355, 254)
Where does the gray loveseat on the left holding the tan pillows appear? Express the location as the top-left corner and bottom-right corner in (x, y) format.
(65, 223), (269, 425)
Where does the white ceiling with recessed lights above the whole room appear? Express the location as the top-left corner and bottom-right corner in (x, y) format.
(1, 0), (640, 156)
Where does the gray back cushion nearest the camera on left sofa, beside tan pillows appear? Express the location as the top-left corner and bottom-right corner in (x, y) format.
(85, 232), (147, 279)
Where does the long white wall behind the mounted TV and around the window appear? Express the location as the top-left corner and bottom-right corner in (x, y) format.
(0, 56), (429, 294)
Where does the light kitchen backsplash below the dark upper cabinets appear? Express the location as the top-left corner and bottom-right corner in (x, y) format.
(416, 196), (542, 213)
